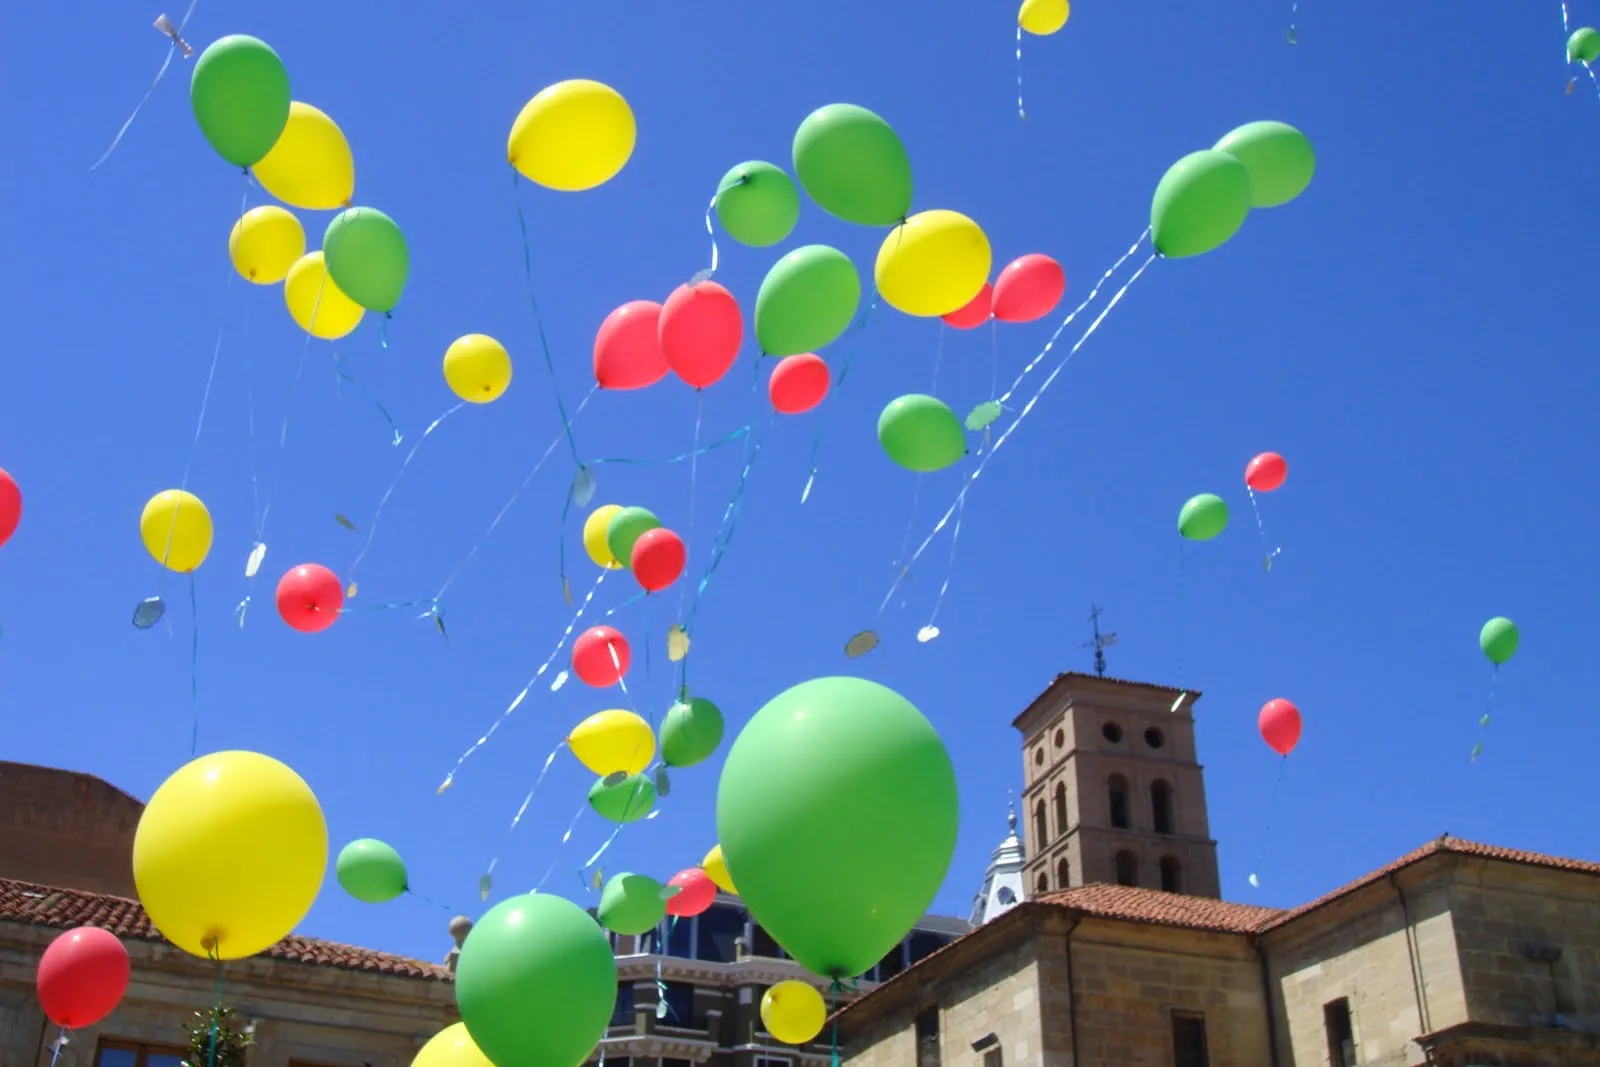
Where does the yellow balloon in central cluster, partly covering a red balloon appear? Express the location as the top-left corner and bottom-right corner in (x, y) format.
(874, 210), (990, 318)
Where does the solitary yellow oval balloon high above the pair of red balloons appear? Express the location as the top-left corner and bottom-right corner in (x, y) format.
(506, 78), (637, 192)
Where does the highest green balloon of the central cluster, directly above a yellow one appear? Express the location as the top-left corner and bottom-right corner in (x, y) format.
(794, 104), (910, 226)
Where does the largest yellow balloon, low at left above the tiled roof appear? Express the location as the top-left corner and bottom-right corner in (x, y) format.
(133, 752), (328, 960)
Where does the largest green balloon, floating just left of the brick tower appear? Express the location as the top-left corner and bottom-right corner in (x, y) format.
(717, 677), (960, 979)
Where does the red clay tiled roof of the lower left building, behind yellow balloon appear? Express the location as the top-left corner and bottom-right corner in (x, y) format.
(0, 878), (451, 981)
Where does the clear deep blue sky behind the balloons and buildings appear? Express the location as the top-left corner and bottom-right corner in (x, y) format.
(0, 0), (1600, 958)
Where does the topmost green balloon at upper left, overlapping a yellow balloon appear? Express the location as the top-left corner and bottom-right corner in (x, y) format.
(189, 34), (290, 166)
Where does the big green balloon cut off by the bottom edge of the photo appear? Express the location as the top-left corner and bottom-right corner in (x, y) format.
(456, 893), (616, 1067)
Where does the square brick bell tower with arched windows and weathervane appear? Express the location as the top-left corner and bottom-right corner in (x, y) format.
(1011, 672), (1222, 897)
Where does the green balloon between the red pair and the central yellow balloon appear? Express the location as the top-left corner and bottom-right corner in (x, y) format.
(755, 245), (861, 355)
